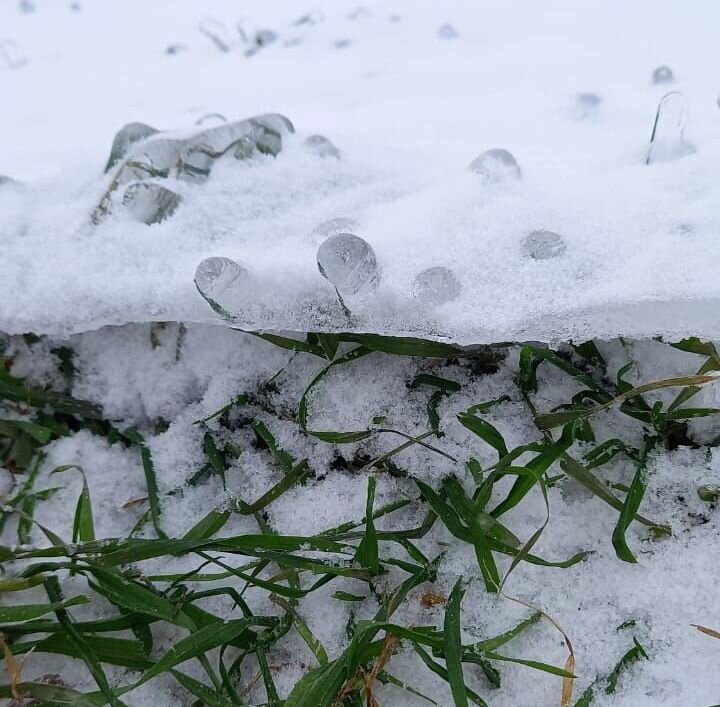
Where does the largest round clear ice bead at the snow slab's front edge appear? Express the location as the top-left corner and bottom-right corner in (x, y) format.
(317, 233), (378, 295)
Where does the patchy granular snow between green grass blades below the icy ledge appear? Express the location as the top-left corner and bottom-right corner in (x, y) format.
(0, 325), (720, 707)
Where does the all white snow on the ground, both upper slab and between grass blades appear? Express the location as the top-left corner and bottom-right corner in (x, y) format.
(0, 0), (720, 707)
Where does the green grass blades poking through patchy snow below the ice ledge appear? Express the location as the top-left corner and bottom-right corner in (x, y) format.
(0, 334), (720, 707)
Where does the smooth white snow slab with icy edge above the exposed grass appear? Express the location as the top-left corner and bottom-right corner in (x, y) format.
(0, 0), (720, 343)
